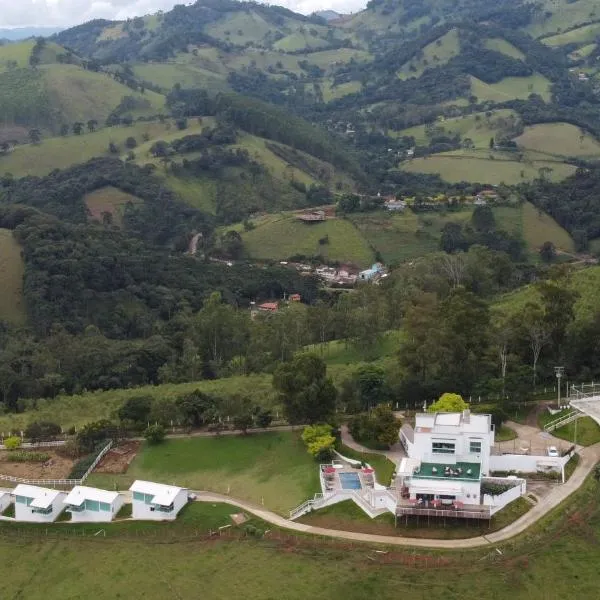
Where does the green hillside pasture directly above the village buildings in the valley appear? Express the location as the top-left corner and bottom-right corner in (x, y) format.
(236, 214), (374, 266)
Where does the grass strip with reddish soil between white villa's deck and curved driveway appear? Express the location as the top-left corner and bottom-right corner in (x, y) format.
(298, 498), (532, 539)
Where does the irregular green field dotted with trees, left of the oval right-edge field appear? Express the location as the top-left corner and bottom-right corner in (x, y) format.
(397, 109), (520, 149)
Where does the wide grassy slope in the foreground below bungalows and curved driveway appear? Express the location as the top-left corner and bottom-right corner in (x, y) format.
(0, 464), (600, 600)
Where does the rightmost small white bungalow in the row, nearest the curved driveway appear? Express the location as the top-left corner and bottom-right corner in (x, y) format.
(129, 480), (188, 521)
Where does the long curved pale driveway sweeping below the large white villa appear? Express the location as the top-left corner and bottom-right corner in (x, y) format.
(195, 444), (600, 549)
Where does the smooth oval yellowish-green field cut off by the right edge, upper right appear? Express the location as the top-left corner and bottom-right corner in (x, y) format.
(515, 123), (600, 157)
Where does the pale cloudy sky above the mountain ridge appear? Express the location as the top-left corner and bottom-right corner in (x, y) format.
(0, 0), (367, 28)
